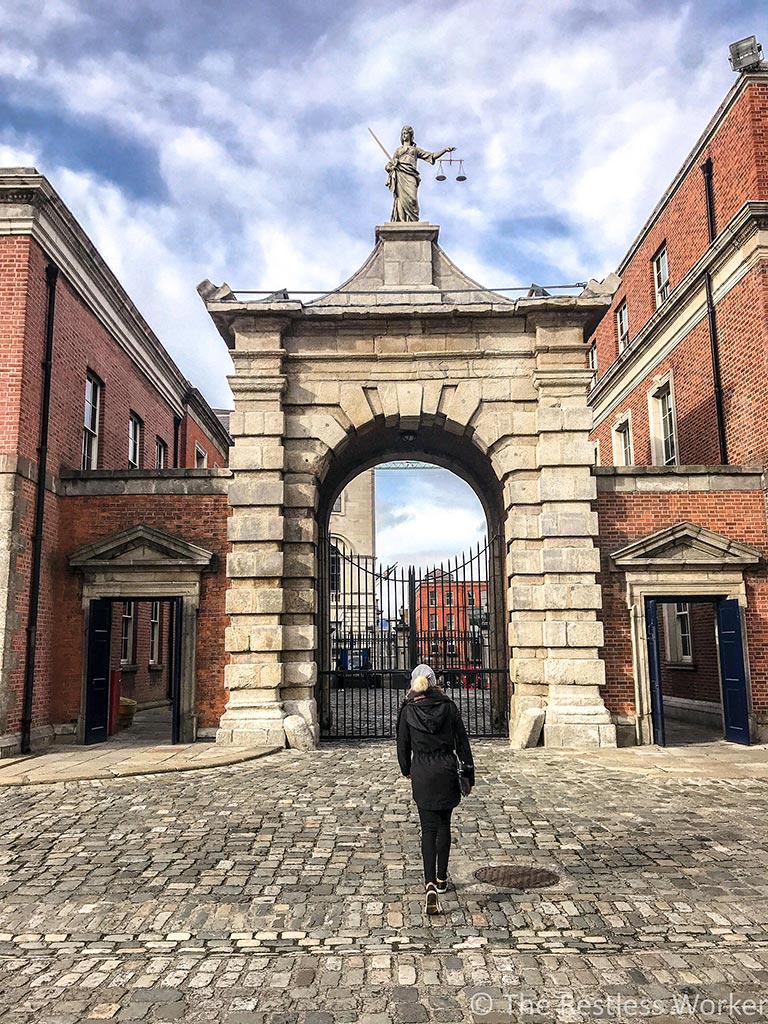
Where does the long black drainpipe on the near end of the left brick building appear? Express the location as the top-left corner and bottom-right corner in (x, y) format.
(22, 263), (58, 754)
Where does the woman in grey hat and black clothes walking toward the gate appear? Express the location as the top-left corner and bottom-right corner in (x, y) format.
(397, 665), (475, 914)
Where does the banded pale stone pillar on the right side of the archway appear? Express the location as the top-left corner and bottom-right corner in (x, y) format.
(508, 313), (616, 748)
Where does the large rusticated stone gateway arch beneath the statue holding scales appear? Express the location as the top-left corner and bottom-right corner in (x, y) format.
(199, 222), (615, 748)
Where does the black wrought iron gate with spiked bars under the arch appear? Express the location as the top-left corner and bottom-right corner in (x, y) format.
(317, 536), (509, 739)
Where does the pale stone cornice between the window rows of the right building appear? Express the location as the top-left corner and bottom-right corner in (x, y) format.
(589, 201), (768, 417)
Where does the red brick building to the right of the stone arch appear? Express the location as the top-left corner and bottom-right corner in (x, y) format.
(590, 66), (768, 742)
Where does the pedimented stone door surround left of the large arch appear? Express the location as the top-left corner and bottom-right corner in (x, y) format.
(70, 525), (213, 743)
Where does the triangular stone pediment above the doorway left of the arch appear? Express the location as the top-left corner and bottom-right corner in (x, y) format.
(70, 526), (213, 571)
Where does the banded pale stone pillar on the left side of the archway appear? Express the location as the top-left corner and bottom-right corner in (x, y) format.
(216, 316), (288, 746)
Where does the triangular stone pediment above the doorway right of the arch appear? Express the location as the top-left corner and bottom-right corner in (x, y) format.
(610, 522), (761, 570)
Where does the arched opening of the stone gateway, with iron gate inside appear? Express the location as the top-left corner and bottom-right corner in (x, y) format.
(316, 419), (510, 738)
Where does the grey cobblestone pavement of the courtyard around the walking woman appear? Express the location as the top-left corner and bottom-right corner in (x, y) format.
(0, 740), (768, 1024)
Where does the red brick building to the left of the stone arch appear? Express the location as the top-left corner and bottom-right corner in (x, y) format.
(0, 168), (229, 752)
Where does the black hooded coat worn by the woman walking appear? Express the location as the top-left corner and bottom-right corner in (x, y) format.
(397, 687), (475, 811)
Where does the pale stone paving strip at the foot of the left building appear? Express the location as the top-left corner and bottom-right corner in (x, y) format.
(0, 743), (280, 786)
